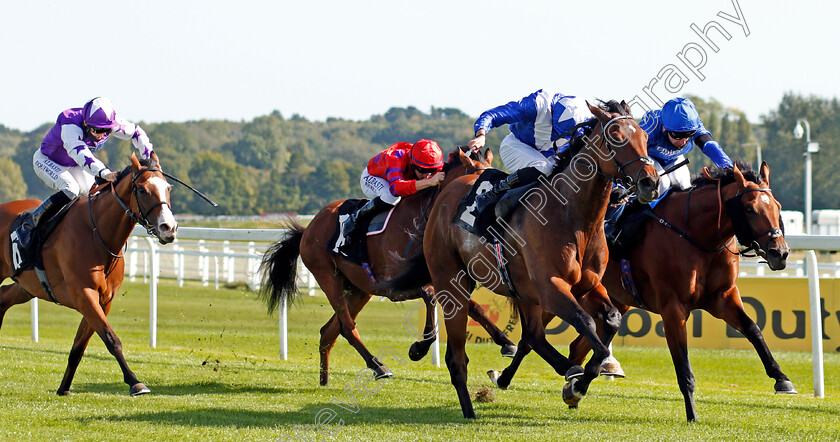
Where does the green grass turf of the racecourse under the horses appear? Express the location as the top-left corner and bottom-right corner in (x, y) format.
(0, 281), (840, 440)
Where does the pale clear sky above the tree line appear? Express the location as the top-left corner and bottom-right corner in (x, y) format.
(0, 0), (840, 131)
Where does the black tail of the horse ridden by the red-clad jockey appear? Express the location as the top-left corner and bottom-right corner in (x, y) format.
(258, 221), (306, 313)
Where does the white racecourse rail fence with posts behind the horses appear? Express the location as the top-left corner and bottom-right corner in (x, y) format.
(23, 226), (840, 397)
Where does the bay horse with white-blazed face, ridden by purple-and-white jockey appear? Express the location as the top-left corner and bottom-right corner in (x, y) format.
(0, 153), (178, 396)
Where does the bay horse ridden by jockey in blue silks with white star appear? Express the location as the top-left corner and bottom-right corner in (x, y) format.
(382, 101), (658, 418)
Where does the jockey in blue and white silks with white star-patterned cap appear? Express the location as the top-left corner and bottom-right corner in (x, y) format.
(468, 89), (594, 211)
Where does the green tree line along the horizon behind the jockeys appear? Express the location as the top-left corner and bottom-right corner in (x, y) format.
(0, 94), (840, 215)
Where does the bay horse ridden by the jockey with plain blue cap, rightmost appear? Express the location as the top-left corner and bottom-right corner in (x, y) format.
(491, 163), (796, 421)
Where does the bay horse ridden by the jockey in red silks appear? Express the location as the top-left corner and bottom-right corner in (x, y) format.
(260, 149), (516, 385)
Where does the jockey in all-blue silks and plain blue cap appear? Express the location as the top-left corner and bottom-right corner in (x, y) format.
(639, 98), (732, 195)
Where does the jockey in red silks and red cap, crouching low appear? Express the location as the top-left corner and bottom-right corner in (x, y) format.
(342, 140), (444, 239)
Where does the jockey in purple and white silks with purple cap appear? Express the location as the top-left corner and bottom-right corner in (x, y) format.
(27, 97), (153, 231)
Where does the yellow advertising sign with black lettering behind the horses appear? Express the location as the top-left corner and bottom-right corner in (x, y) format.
(412, 277), (840, 352)
